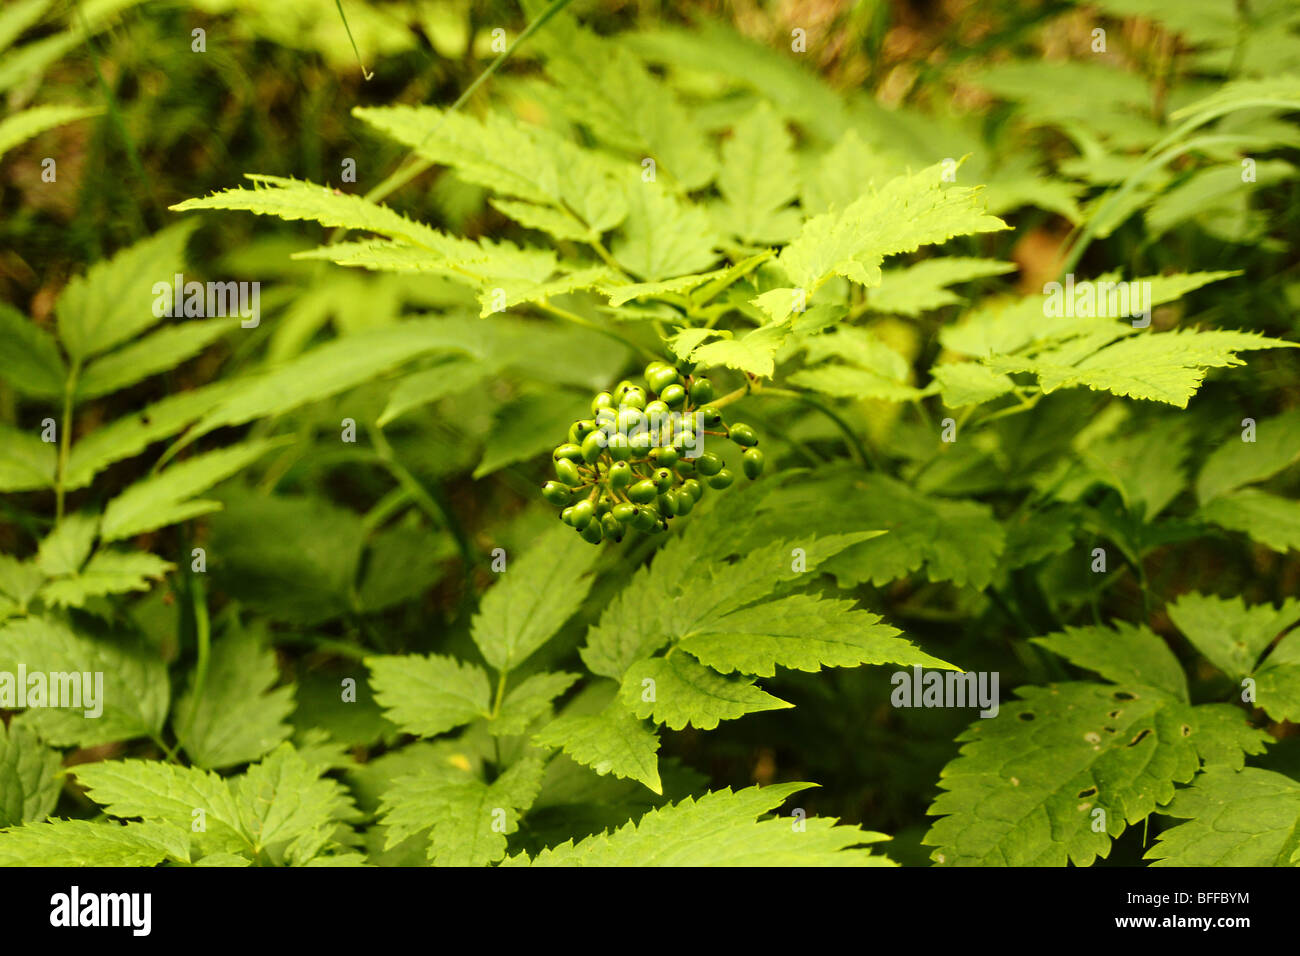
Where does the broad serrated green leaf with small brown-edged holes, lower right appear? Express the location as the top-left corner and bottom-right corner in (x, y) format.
(923, 683), (1244, 866)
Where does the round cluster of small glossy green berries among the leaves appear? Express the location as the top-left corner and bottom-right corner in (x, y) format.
(542, 362), (763, 544)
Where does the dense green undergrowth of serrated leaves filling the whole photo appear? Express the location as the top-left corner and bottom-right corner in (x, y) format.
(0, 0), (1300, 866)
